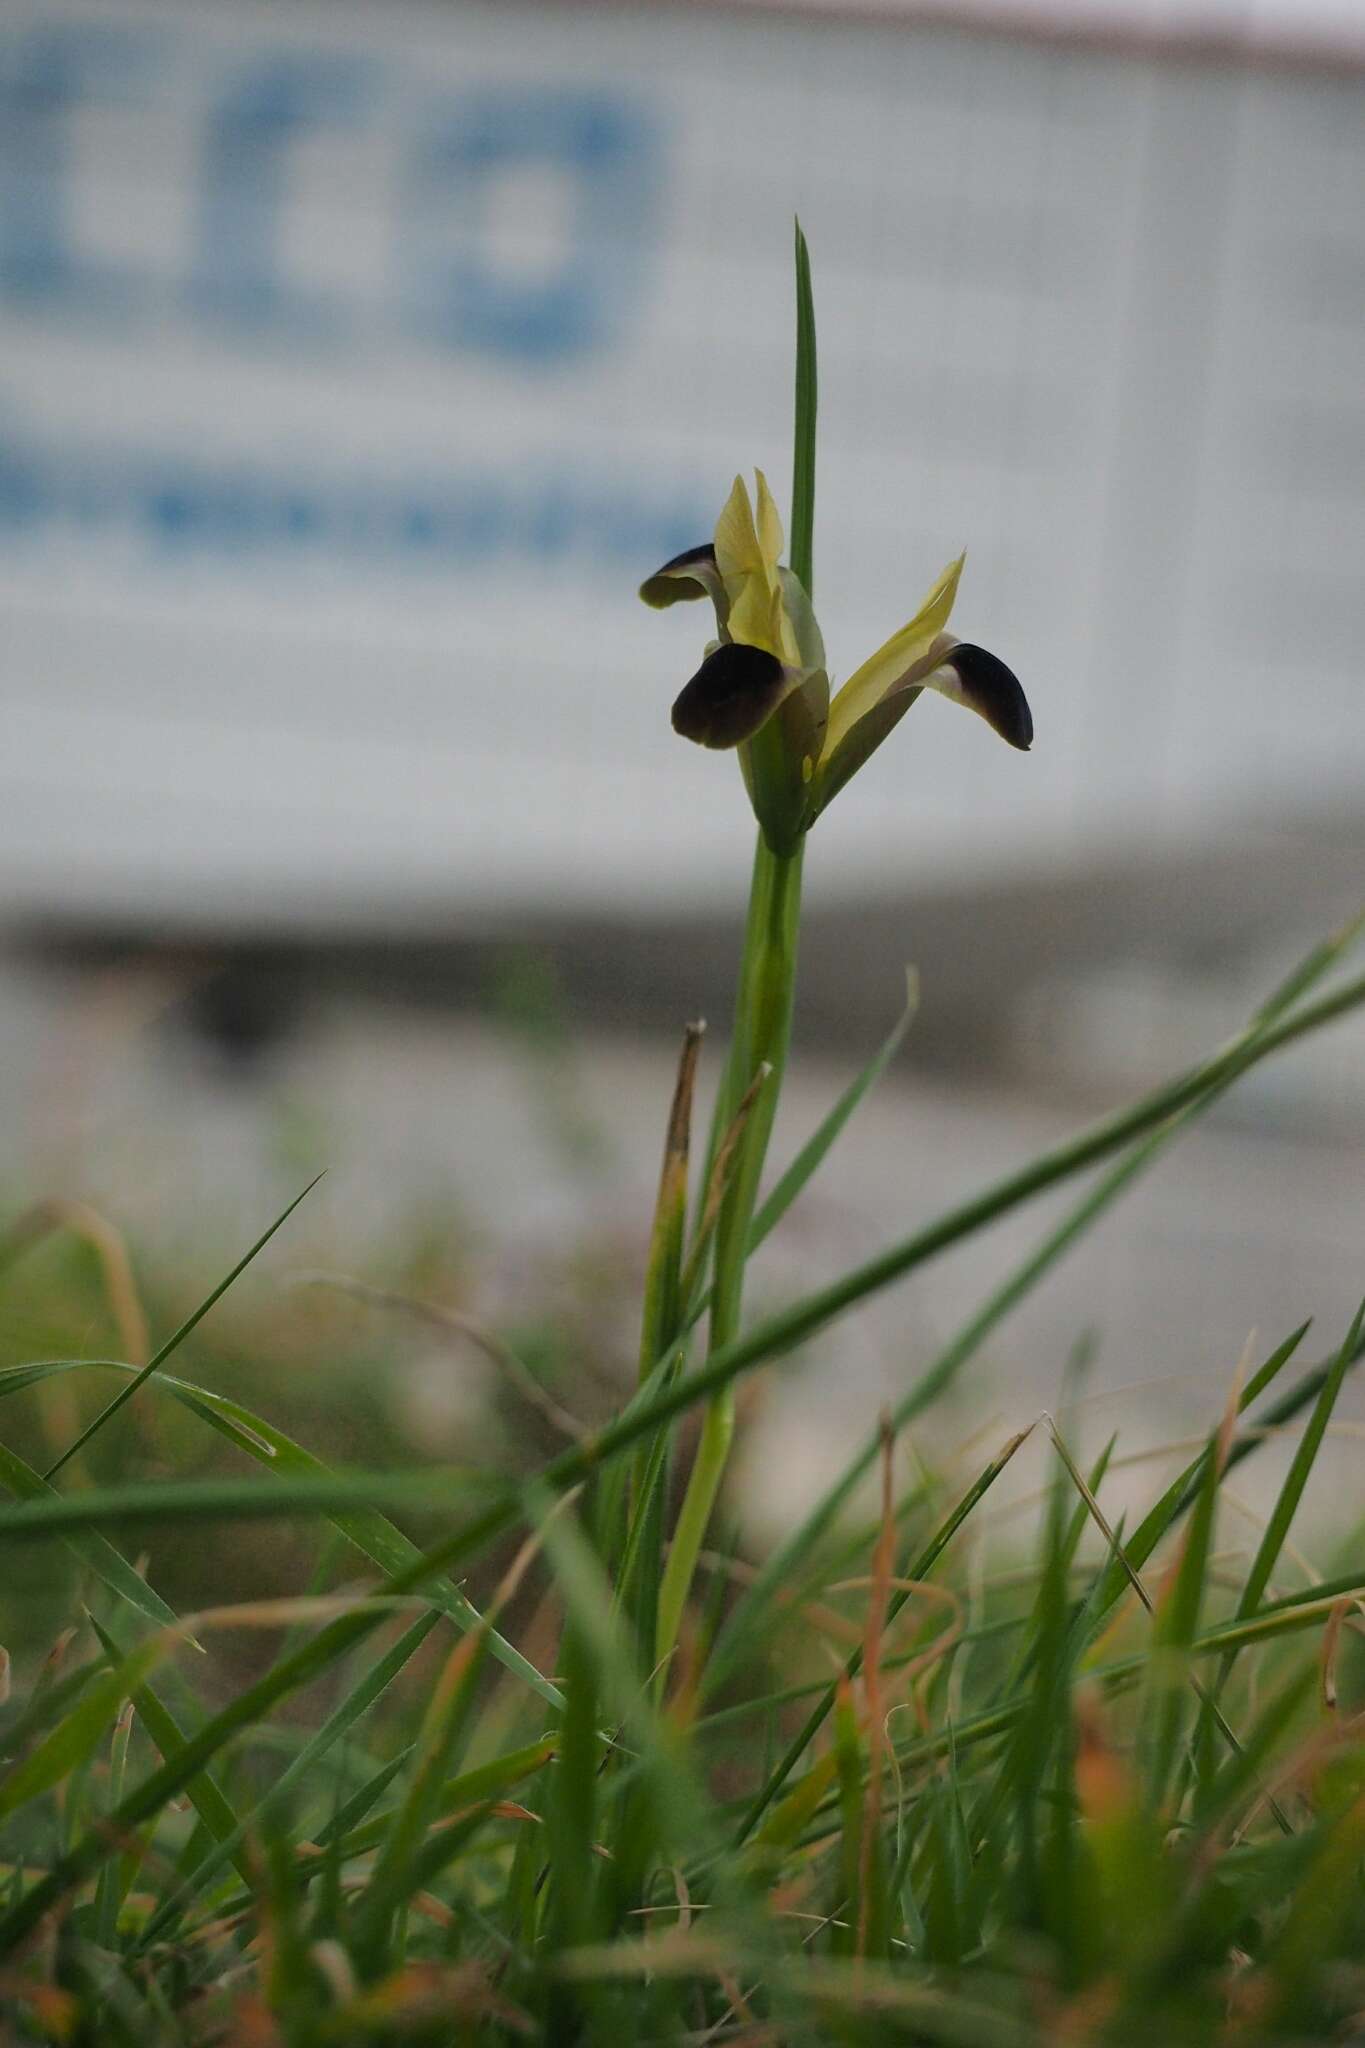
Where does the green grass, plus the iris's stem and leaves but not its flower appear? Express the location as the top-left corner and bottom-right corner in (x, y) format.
(0, 224), (1365, 2048)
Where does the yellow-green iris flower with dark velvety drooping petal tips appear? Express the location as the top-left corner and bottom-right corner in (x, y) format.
(641, 469), (1033, 854)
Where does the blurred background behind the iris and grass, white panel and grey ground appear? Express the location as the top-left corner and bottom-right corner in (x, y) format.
(0, 0), (1365, 1548)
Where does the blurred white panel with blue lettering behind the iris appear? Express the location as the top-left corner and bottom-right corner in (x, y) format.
(0, 0), (1365, 926)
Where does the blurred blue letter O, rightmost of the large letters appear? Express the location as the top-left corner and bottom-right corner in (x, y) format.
(403, 88), (659, 365)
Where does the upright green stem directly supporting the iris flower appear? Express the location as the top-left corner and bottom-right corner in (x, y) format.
(655, 834), (804, 1661)
